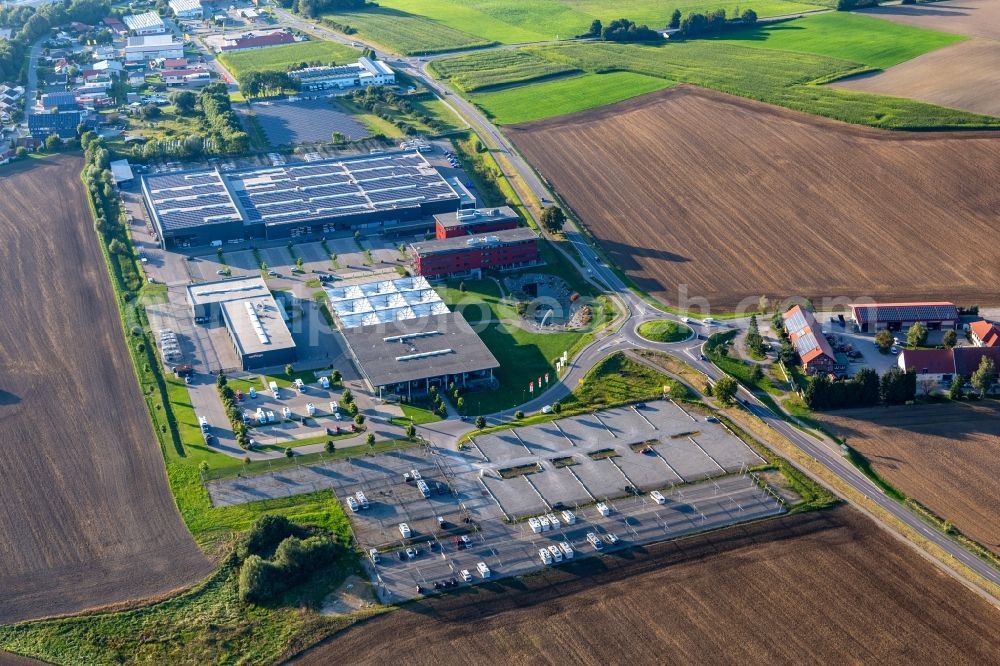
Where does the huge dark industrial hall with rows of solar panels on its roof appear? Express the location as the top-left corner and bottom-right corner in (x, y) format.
(142, 151), (475, 248)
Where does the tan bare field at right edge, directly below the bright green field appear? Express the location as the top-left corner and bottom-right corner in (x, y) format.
(831, 39), (1000, 116)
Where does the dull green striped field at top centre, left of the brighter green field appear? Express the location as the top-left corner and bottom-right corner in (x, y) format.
(323, 5), (495, 55)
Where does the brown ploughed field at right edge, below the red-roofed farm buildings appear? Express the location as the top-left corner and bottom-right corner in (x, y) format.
(819, 402), (1000, 553)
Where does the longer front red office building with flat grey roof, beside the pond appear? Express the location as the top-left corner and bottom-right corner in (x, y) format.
(410, 227), (538, 277)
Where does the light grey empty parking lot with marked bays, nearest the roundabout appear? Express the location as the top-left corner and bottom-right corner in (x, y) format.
(473, 401), (763, 518)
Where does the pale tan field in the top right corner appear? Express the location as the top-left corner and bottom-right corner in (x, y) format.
(858, 0), (1000, 40)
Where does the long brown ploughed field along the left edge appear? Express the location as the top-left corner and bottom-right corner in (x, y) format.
(0, 157), (212, 623)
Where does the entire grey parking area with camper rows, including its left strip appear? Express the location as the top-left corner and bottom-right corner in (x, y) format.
(209, 402), (784, 601)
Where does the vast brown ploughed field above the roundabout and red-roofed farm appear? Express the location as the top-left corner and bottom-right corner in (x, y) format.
(507, 86), (1000, 310)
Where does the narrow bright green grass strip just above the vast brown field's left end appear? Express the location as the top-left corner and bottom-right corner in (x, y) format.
(471, 72), (673, 125)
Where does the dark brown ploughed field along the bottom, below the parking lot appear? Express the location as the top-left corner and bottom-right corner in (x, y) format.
(294, 507), (1000, 666)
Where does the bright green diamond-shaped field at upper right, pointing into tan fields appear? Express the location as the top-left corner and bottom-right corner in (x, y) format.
(720, 12), (967, 69)
